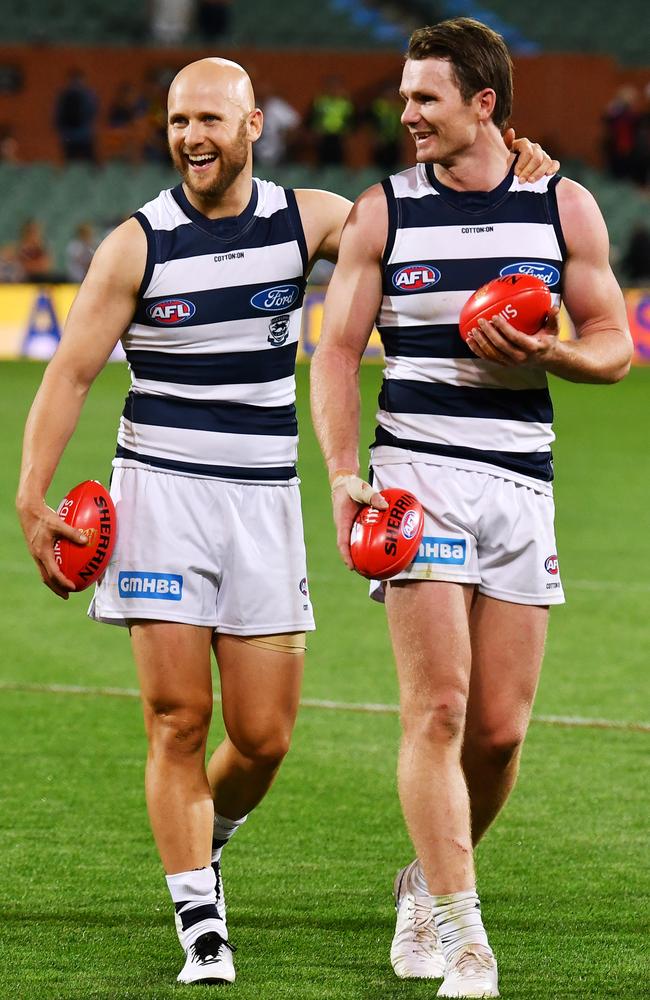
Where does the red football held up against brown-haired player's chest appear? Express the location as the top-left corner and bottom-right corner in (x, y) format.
(458, 274), (551, 340)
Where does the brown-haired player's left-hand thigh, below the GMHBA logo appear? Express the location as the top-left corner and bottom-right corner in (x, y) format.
(386, 581), (474, 712)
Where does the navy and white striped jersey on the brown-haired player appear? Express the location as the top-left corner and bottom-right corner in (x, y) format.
(372, 164), (566, 493)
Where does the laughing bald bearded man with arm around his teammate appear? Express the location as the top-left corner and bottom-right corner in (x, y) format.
(17, 59), (549, 983)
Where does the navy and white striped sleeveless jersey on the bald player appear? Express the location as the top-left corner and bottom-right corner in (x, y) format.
(114, 179), (307, 483)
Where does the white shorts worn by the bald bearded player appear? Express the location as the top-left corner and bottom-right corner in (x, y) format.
(88, 468), (315, 635)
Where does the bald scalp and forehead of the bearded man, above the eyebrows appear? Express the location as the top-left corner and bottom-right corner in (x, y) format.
(168, 57), (255, 115)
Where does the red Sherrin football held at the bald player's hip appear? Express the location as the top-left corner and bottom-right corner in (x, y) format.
(54, 479), (117, 590)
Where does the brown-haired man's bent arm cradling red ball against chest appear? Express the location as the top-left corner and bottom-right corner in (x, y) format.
(468, 179), (633, 383)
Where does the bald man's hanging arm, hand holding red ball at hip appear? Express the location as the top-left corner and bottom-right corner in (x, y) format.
(16, 219), (146, 597)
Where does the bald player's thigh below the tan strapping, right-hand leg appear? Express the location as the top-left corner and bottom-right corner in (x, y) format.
(214, 634), (304, 756)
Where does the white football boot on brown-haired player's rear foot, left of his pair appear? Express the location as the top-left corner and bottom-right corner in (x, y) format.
(390, 859), (445, 979)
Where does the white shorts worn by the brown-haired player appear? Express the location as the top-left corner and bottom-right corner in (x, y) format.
(370, 462), (564, 605)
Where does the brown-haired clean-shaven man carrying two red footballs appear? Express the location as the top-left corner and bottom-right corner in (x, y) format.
(312, 18), (632, 997)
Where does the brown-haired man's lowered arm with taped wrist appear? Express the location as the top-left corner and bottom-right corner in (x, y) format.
(311, 185), (388, 568)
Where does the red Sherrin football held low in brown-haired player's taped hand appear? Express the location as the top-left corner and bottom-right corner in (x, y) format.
(350, 489), (424, 580)
